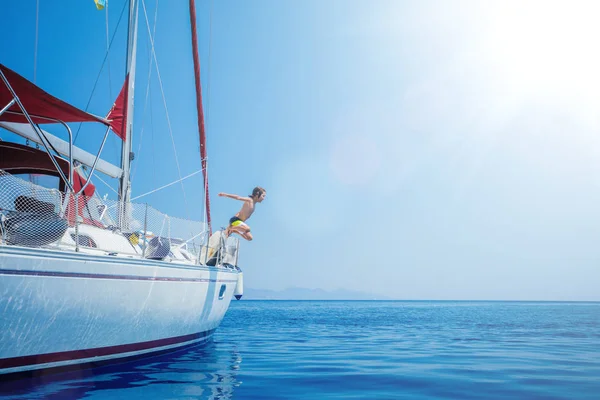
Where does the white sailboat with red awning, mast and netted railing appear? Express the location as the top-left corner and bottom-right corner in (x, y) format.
(0, 0), (243, 379)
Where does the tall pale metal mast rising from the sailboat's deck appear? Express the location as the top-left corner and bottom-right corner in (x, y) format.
(119, 0), (138, 228)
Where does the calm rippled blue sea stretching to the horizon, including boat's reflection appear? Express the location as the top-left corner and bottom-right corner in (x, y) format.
(1, 300), (600, 400)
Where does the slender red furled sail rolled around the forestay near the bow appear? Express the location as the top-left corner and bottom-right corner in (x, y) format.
(190, 0), (212, 235)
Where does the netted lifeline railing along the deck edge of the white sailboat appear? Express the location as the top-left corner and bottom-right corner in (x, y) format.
(0, 170), (239, 266)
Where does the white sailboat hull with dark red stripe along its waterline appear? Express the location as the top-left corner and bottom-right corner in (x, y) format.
(0, 246), (238, 375)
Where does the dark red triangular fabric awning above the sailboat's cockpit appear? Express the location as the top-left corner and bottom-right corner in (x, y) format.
(0, 64), (108, 124)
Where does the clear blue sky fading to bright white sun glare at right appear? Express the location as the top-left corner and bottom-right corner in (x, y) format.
(0, 0), (600, 300)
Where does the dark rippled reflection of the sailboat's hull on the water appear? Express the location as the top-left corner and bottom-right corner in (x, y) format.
(0, 339), (242, 400)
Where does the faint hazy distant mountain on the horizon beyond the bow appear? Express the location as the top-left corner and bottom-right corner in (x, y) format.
(243, 287), (389, 300)
